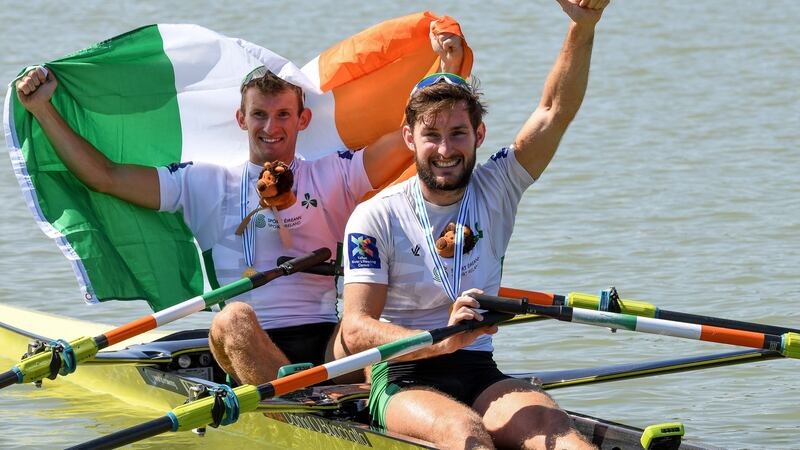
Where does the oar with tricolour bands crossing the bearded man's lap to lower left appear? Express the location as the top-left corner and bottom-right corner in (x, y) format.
(70, 312), (513, 450)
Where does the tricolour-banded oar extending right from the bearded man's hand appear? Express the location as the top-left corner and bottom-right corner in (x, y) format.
(469, 294), (800, 358)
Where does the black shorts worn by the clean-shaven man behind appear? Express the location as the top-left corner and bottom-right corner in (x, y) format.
(264, 322), (336, 366)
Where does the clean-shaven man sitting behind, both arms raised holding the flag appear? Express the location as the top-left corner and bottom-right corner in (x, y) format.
(16, 33), (463, 384)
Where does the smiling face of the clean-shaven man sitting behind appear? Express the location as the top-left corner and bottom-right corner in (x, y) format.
(236, 88), (311, 165)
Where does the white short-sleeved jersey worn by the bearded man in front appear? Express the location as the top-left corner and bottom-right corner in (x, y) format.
(344, 149), (534, 351)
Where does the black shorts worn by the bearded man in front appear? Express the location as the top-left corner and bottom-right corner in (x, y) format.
(370, 350), (511, 422)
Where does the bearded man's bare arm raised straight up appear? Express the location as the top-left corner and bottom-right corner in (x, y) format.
(514, 0), (609, 179)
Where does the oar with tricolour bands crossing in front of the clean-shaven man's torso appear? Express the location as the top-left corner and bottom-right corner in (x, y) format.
(0, 248), (331, 389)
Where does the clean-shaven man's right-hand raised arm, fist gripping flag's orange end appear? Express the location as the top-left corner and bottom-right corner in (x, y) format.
(364, 29), (464, 189)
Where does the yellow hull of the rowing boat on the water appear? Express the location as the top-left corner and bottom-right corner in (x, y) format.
(0, 304), (430, 450)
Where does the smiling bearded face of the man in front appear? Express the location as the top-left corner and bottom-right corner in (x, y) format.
(403, 102), (486, 206)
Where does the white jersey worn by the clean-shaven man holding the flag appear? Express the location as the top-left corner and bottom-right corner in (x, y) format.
(158, 151), (372, 329)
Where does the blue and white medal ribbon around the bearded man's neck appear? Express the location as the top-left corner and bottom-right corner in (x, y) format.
(411, 177), (472, 301)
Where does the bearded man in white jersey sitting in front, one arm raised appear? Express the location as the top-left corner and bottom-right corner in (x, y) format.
(342, 0), (608, 448)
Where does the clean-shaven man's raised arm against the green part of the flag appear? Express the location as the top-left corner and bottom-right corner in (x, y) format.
(16, 68), (161, 209)
